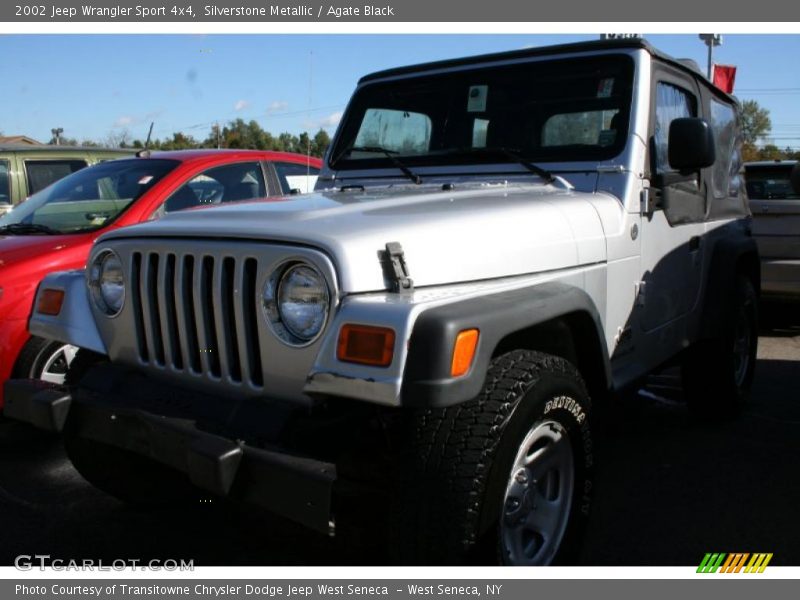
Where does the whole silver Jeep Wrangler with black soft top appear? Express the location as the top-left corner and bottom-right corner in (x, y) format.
(5, 40), (759, 565)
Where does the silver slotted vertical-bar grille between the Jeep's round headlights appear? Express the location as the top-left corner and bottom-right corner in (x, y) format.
(130, 250), (264, 388)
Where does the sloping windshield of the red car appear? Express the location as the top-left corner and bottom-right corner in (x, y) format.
(0, 158), (180, 233)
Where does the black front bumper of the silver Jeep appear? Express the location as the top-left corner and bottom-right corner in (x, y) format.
(4, 379), (337, 534)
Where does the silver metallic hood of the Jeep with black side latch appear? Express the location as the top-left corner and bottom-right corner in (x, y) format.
(101, 183), (613, 293)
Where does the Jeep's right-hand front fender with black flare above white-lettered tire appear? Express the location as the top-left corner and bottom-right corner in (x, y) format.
(304, 269), (610, 406)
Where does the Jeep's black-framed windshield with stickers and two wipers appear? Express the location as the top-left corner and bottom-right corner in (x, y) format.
(330, 55), (633, 169)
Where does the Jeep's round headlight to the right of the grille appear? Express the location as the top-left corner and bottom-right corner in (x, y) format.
(263, 263), (330, 345)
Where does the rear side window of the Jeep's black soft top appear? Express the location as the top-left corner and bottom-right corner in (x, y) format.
(710, 98), (742, 199)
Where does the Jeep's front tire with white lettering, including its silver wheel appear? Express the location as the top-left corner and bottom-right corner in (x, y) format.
(397, 350), (593, 565)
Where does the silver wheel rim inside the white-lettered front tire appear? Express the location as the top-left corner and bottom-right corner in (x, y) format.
(500, 421), (575, 565)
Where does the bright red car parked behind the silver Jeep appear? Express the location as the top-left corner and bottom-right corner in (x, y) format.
(0, 150), (321, 408)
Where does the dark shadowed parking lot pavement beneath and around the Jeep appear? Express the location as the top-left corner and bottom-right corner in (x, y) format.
(0, 306), (800, 566)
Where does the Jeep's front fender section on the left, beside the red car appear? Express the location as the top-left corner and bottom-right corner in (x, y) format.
(28, 269), (107, 354)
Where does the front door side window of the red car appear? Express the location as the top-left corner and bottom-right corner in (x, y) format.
(159, 162), (267, 217)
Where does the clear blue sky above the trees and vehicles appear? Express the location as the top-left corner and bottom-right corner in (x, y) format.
(0, 34), (800, 148)
